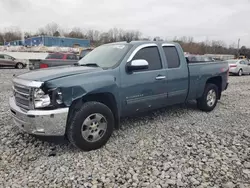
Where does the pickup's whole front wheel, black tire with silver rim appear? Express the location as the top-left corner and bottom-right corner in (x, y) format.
(66, 101), (115, 151)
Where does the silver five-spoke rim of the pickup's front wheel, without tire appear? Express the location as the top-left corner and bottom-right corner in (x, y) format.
(81, 113), (108, 142)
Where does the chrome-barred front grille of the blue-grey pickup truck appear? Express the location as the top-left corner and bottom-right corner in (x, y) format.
(13, 83), (32, 110)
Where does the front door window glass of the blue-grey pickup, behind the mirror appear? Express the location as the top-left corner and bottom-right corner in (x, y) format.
(133, 46), (162, 71)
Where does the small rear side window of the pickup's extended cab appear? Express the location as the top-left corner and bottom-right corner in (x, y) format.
(163, 46), (180, 69)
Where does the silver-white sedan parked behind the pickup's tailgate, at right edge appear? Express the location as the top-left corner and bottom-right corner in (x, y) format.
(227, 59), (250, 76)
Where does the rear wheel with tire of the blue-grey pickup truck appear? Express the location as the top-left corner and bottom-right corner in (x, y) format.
(197, 84), (219, 112)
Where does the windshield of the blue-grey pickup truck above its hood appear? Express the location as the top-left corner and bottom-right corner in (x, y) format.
(79, 44), (132, 68)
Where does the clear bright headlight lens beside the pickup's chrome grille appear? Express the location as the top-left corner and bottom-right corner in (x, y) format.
(34, 89), (50, 108)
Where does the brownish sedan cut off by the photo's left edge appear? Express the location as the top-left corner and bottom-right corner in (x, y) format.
(0, 54), (27, 69)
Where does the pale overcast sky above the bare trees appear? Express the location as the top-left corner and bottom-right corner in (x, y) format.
(0, 0), (250, 47)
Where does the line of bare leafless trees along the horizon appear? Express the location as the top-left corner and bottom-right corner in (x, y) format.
(0, 23), (250, 58)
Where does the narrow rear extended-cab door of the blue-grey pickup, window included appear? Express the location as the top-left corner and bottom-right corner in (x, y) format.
(162, 44), (189, 105)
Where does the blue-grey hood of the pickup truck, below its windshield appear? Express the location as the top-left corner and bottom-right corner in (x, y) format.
(17, 66), (103, 82)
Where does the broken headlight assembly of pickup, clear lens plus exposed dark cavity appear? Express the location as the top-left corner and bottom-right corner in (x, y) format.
(34, 88), (63, 108)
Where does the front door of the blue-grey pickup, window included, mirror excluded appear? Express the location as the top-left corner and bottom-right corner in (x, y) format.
(120, 44), (167, 116)
